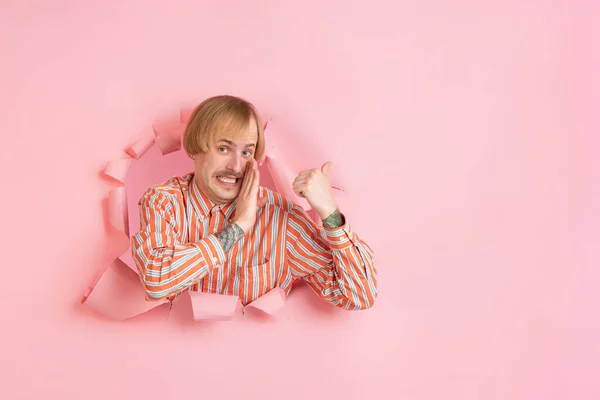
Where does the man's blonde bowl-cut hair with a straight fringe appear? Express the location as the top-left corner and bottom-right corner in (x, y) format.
(183, 95), (265, 160)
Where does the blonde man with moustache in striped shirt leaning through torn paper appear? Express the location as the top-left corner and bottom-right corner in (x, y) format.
(132, 96), (377, 310)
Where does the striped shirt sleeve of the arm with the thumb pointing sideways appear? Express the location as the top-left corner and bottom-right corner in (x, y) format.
(286, 206), (377, 310)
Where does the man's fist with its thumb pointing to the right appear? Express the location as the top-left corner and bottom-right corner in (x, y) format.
(292, 161), (338, 219)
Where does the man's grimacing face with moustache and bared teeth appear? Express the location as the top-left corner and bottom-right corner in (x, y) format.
(194, 118), (258, 204)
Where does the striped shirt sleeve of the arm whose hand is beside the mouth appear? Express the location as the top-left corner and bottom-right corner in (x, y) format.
(131, 188), (225, 300)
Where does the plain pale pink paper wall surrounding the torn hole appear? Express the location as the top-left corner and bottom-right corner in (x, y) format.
(0, 0), (600, 400)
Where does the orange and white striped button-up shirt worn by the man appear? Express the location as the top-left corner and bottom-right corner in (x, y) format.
(131, 173), (377, 310)
